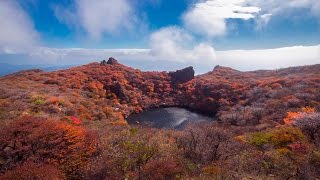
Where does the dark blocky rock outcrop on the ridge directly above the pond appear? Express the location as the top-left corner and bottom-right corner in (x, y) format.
(169, 66), (194, 83)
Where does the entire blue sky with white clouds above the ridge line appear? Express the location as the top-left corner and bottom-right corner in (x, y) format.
(0, 0), (320, 73)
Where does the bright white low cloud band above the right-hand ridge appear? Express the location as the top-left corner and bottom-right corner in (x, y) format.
(216, 45), (320, 70)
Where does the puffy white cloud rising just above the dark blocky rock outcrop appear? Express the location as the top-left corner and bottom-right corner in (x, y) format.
(150, 27), (215, 63)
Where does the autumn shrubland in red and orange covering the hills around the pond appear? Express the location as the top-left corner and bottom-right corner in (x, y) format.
(0, 59), (320, 179)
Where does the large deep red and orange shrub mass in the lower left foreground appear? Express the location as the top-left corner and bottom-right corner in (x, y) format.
(0, 117), (96, 177)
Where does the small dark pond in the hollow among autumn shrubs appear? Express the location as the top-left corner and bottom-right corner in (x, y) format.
(127, 107), (213, 129)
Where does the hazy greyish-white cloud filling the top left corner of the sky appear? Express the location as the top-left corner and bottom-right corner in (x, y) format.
(0, 0), (39, 49)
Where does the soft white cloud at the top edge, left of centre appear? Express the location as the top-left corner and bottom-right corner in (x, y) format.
(54, 0), (138, 40)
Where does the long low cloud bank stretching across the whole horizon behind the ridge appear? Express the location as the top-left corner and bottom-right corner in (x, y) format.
(0, 45), (320, 73)
